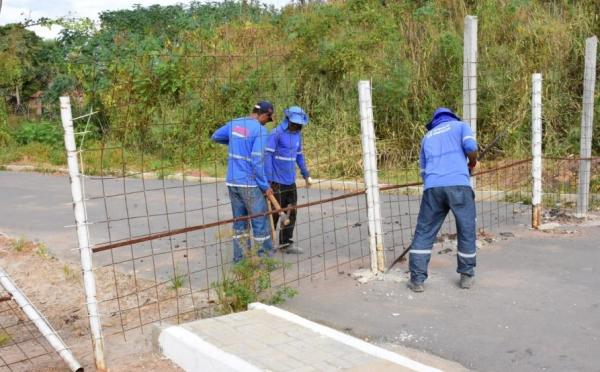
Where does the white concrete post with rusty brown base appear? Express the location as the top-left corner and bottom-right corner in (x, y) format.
(531, 74), (542, 229)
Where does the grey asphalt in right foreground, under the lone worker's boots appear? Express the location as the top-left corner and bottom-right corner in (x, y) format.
(284, 222), (600, 372)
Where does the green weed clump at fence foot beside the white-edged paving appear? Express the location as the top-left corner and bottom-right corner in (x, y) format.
(212, 254), (297, 314)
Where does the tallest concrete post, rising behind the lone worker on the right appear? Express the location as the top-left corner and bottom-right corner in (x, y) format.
(462, 16), (477, 189)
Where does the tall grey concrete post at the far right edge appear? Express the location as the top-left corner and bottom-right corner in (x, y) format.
(576, 36), (598, 218)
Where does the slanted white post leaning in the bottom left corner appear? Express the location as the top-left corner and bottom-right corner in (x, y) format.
(0, 267), (83, 372)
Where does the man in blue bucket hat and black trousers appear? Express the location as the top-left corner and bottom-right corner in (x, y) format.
(265, 106), (312, 254)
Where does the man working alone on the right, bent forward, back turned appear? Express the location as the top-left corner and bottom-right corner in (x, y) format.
(408, 107), (477, 292)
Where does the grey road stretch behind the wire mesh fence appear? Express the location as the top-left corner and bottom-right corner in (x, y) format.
(0, 172), (522, 288)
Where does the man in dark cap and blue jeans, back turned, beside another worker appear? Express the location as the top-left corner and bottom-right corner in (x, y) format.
(211, 101), (273, 263)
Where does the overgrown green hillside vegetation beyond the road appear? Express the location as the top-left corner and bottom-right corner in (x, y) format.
(0, 0), (600, 178)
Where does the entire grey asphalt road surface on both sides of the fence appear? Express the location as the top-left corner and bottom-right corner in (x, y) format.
(0, 172), (600, 371)
